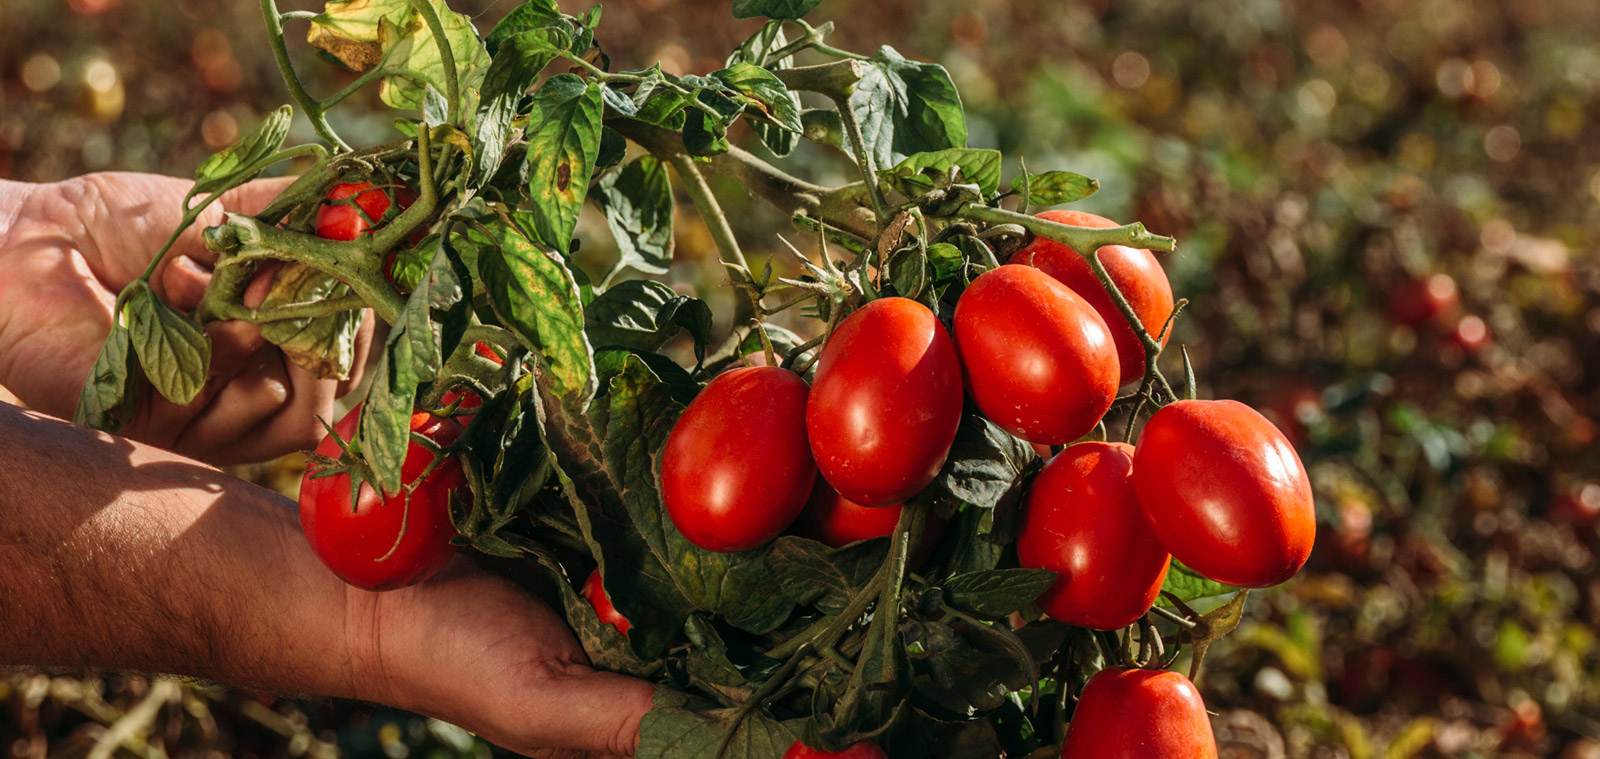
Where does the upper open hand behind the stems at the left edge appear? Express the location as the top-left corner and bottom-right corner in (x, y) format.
(0, 173), (371, 463)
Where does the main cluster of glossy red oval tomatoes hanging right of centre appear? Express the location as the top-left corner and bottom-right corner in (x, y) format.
(661, 211), (1315, 629)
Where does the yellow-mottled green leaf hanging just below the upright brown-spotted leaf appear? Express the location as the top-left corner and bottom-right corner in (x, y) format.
(462, 224), (595, 404)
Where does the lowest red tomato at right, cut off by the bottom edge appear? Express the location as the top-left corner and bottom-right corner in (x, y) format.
(1061, 666), (1216, 759)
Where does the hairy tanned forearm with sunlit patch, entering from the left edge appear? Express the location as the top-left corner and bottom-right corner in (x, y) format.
(0, 405), (363, 697)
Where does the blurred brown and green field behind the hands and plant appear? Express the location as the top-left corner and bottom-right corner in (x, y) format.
(0, 0), (1600, 759)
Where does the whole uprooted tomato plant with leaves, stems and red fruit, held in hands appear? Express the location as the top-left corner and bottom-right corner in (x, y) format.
(62, 0), (1312, 759)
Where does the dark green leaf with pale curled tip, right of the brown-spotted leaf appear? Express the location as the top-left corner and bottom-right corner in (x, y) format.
(589, 155), (677, 280)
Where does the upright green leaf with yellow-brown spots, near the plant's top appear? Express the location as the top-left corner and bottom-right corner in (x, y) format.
(526, 74), (603, 255)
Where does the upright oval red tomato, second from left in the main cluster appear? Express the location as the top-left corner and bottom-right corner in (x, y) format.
(805, 298), (962, 506)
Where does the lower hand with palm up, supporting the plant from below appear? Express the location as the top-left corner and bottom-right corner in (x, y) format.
(346, 557), (654, 759)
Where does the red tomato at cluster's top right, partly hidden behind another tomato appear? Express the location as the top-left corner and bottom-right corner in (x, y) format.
(1011, 210), (1174, 384)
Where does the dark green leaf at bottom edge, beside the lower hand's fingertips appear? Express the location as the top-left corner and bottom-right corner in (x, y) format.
(634, 689), (797, 759)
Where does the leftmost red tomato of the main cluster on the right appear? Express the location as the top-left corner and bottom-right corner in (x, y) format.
(661, 367), (816, 552)
